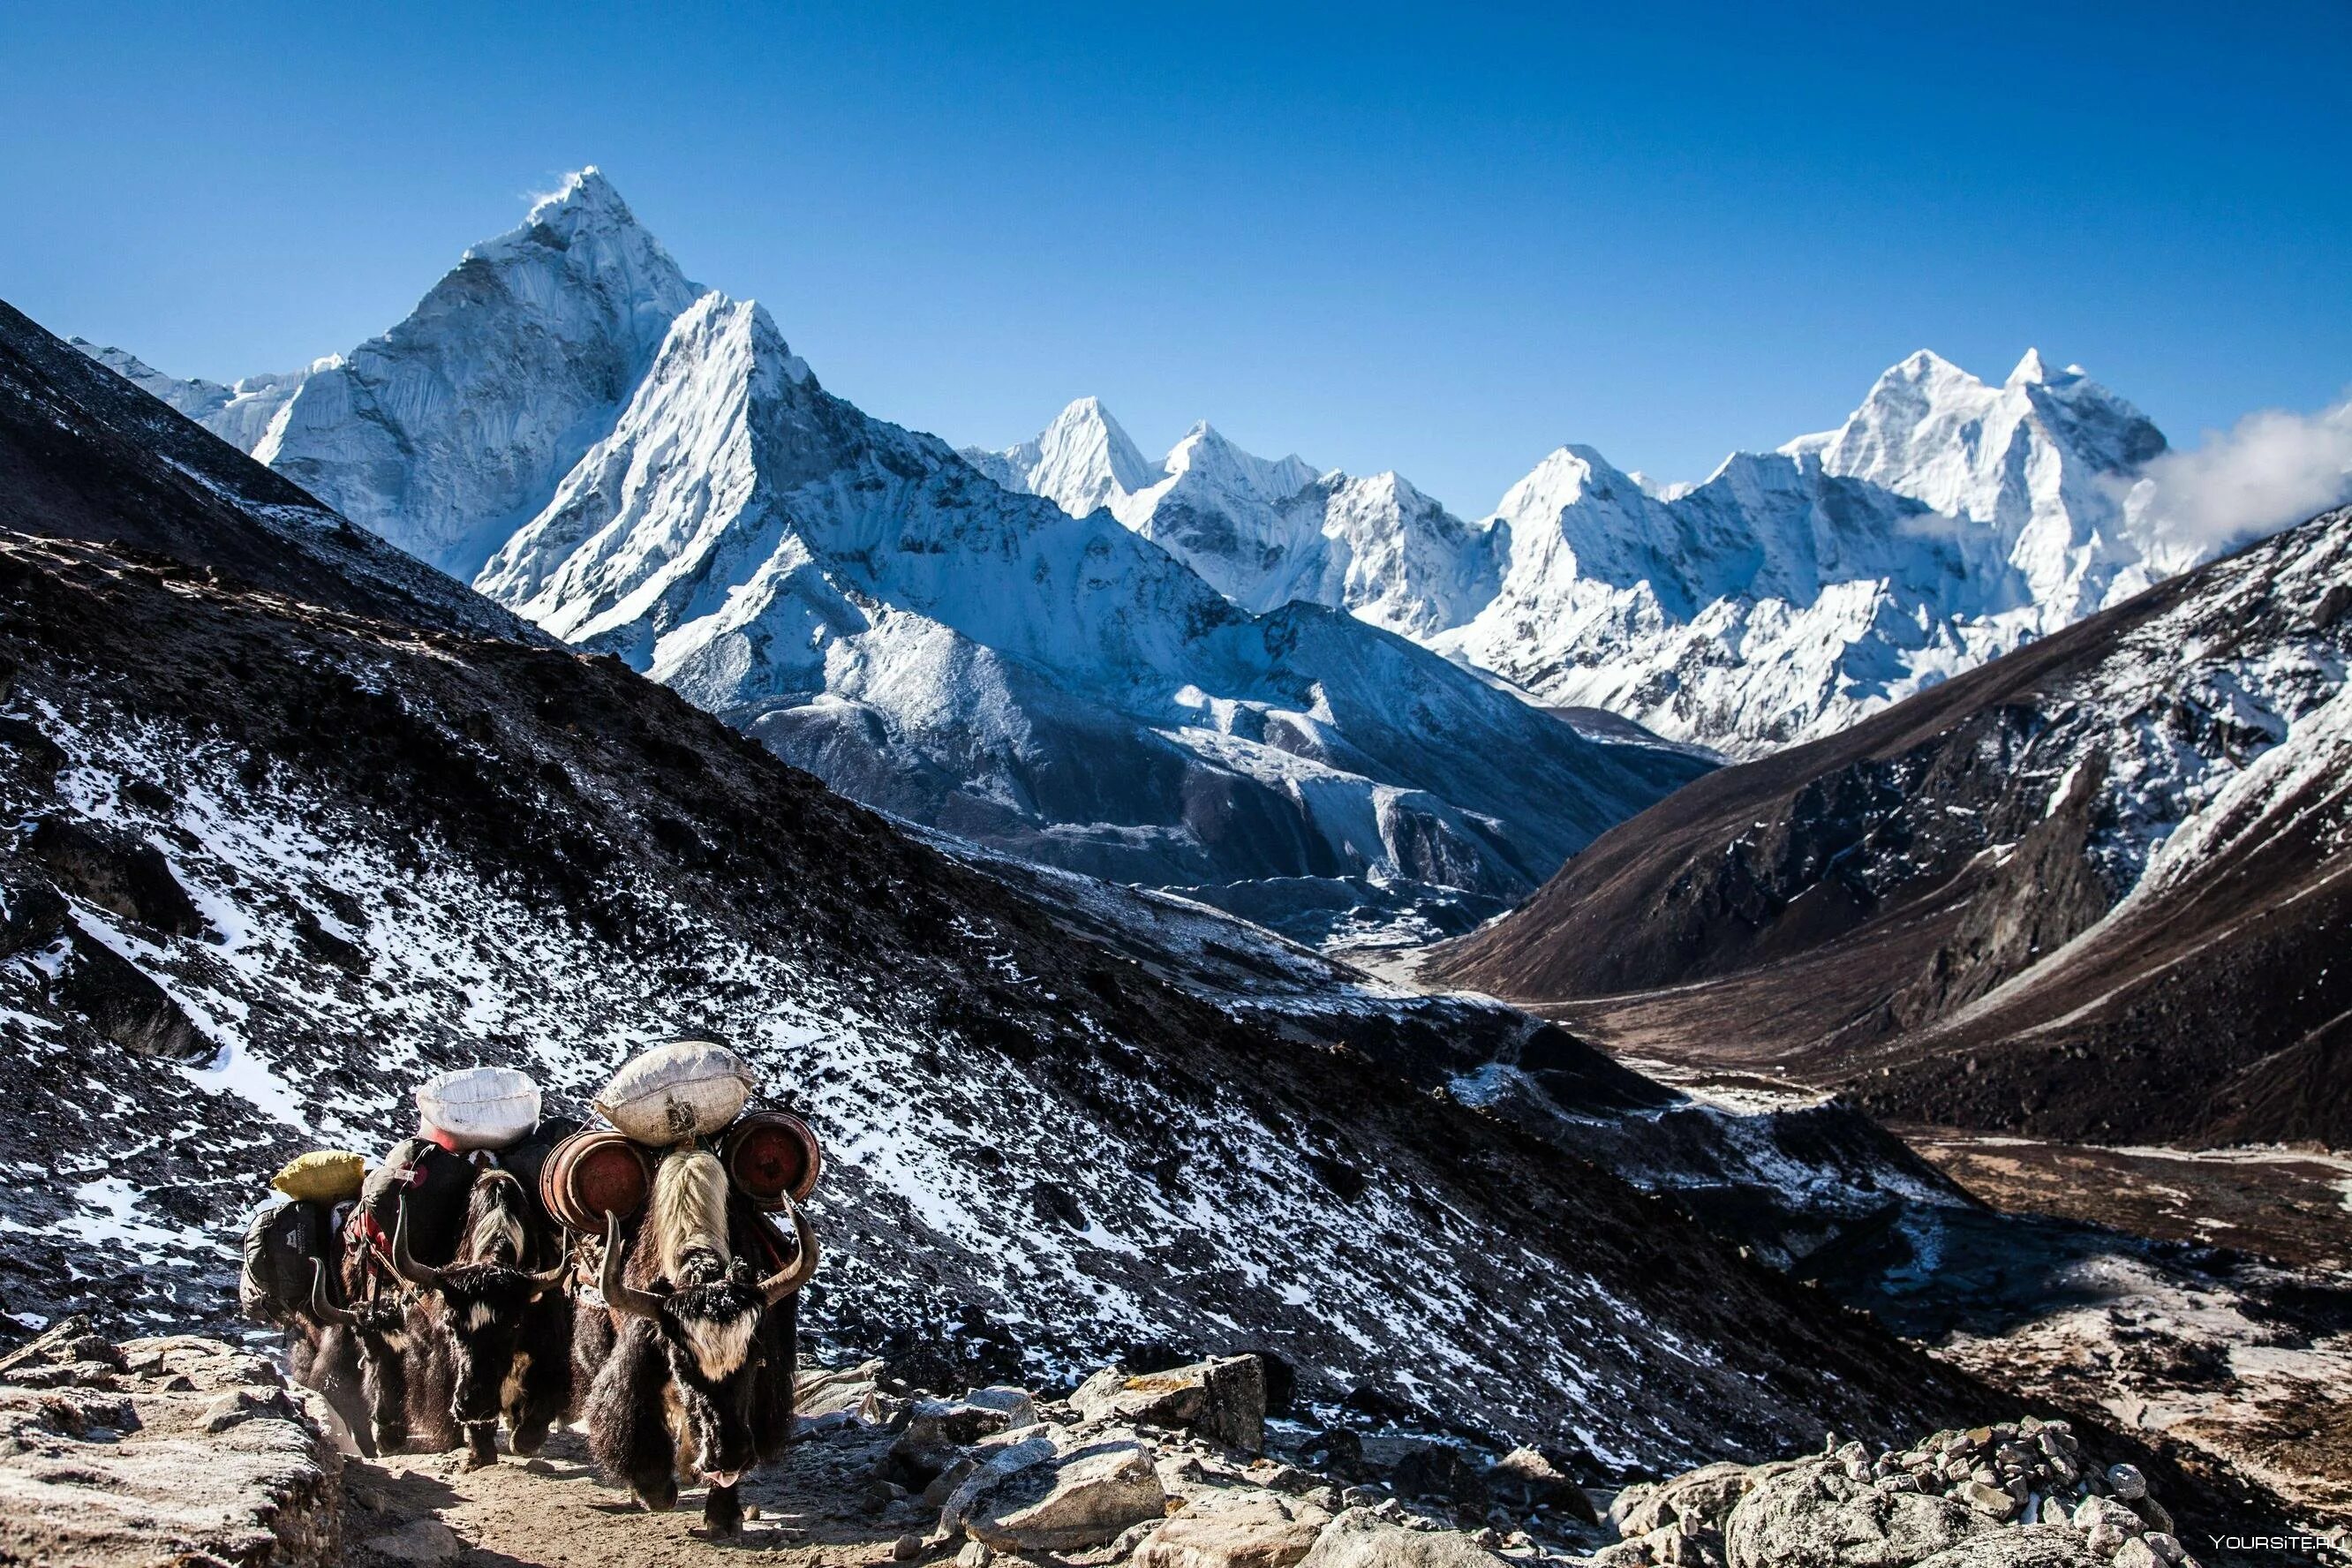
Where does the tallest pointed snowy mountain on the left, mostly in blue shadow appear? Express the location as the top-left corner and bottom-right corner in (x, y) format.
(82, 170), (1703, 936)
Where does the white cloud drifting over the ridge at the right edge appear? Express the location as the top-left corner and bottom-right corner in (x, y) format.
(2124, 400), (2352, 554)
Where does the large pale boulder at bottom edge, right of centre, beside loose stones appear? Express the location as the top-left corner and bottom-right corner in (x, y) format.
(1724, 1458), (1999, 1568)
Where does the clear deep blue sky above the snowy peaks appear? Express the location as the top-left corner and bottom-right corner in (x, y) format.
(0, 0), (2352, 512)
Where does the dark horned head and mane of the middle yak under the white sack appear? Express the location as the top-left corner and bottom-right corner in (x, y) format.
(393, 1166), (569, 1460)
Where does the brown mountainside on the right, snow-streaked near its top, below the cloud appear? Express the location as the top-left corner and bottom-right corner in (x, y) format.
(1442, 510), (2352, 1145)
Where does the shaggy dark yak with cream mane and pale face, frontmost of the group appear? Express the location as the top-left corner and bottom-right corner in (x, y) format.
(588, 1147), (816, 1540)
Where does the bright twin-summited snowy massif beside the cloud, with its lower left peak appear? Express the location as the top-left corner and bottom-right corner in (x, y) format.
(1437, 351), (2192, 755)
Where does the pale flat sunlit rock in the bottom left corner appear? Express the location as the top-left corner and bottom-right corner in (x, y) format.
(0, 1323), (341, 1568)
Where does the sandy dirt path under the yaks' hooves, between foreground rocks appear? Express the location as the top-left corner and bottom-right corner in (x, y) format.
(343, 1427), (920, 1568)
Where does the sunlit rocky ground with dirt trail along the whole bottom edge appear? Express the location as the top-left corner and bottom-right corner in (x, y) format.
(0, 1321), (2328, 1568)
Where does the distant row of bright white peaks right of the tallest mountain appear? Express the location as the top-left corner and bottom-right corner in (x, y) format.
(964, 352), (2204, 755)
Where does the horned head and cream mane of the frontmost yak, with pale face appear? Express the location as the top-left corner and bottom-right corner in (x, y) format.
(602, 1150), (816, 1488)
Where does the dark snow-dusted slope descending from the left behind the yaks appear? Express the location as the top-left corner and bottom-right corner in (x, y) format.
(0, 291), (1985, 1469)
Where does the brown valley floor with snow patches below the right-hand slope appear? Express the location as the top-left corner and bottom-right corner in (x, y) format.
(1383, 952), (2352, 1523)
